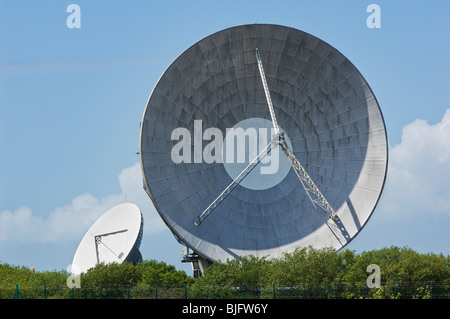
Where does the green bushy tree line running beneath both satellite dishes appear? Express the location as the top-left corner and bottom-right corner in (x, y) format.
(0, 246), (450, 298)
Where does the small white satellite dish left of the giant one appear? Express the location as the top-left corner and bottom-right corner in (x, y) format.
(72, 203), (144, 273)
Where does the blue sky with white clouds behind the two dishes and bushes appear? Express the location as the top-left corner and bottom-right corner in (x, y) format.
(0, 0), (450, 272)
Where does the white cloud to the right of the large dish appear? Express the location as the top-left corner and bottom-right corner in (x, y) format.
(380, 109), (450, 218)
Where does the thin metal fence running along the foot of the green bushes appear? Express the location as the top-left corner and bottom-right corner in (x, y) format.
(4, 282), (450, 299)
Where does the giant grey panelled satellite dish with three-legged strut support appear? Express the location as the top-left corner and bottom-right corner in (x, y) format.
(140, 24), (388, 272)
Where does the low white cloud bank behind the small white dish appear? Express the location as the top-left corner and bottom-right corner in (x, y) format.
(0, 164), (167, 244)
